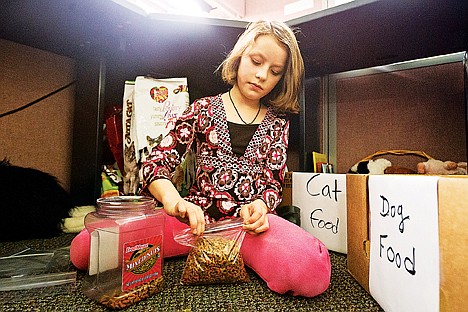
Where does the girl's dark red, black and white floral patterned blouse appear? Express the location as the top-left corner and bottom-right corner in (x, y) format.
(141, 95), (289, 222)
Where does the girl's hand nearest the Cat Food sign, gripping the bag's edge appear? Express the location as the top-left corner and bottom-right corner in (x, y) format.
(240, 199), (270, 234)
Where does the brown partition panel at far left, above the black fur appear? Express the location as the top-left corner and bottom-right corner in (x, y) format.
(0, 39), (75, 190)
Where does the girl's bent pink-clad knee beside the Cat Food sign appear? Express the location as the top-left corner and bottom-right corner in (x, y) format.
(241, 214), (331, 297)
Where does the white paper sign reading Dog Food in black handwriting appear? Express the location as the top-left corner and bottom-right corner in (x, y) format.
(368, 175), (439, 312)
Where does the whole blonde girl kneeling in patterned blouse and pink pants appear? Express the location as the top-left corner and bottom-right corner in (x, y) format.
(72, 21), (331, 297)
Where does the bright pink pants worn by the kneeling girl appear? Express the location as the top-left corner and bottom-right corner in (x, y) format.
(70, 214), (331, 297)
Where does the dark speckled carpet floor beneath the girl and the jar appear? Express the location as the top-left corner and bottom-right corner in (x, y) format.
(0, 234), (383, 312)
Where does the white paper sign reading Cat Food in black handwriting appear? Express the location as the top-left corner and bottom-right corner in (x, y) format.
(292, 172), (348, 253)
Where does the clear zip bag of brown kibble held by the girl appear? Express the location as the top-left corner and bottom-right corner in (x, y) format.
(174, 219), (250, 285)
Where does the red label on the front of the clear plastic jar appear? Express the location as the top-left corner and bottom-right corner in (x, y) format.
(122, 235), (162, 291)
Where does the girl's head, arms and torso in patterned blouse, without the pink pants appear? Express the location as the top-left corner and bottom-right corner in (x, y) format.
(142, 22), (304, 234)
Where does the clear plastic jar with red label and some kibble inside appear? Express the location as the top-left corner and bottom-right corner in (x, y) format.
(83, 196), (164, 309)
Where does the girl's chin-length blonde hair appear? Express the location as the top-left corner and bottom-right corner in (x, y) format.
(218, 21), (304, 113)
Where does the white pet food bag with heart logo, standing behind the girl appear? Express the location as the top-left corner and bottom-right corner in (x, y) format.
(122, 76), (190, 195)
